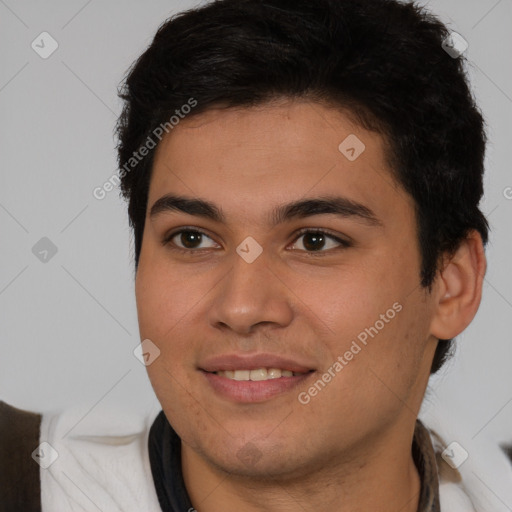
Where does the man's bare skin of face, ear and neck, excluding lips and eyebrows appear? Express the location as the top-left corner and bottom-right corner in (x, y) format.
(136, 99), (485, 512)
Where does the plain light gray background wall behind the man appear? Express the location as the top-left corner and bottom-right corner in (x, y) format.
(0, 0), (512, 440)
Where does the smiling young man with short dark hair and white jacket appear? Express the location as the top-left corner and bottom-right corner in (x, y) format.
(1, 0), (512, 512)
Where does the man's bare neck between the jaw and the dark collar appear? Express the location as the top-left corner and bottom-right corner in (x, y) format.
(182, 422), (421, 512)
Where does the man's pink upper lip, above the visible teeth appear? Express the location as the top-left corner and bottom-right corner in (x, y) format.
(199, 353), (313, 373)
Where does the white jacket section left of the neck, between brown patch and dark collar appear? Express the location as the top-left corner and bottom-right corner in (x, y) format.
(41, 405), (160, 512)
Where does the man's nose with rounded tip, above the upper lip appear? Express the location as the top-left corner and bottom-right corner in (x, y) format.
(209, 251), (294, 335)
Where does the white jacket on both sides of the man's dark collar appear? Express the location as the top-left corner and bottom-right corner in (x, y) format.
(40, 407), (512, 512)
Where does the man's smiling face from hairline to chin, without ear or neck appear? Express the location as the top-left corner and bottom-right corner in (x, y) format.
(136, 102), (437, 476)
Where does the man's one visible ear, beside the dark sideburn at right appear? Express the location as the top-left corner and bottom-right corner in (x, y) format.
(430, 231), (487, 340)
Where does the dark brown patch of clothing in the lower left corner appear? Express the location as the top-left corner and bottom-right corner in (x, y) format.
(0, 400), (42, 512)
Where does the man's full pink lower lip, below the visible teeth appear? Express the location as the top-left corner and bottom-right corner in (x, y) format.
(201, 370), (314, 403)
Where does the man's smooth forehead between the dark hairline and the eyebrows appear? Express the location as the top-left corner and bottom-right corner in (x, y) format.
(148, 101), (411, 227)
